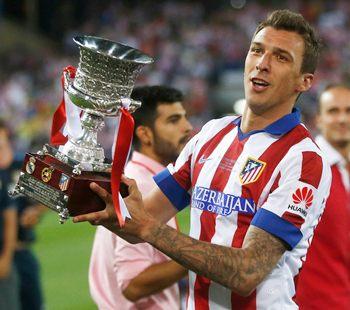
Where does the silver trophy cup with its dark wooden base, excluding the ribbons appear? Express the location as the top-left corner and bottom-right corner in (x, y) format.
(12, 36), (153, 223)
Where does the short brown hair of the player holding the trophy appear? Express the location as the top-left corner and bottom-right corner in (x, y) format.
(253, 10), (321, 73)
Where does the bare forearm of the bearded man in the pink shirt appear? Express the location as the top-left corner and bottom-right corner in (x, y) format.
(122, 261), (187, 302)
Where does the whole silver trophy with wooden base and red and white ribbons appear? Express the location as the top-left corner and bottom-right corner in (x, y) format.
(14, 36), (153, 223)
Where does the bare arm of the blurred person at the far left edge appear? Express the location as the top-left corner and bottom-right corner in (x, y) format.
(0, 208), (17, 279)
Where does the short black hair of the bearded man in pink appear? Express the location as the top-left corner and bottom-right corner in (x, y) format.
(131, 85), (184, 149)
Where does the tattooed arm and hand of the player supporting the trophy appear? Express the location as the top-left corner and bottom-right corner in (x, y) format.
(74, 178), (287, 296)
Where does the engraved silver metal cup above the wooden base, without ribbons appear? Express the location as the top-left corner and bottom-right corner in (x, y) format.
(63, 36), (153, 170)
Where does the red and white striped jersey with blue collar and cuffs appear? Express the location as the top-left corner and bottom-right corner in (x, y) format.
(155, 110), (331, 310)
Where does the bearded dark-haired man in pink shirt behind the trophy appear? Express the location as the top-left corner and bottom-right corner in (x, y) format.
(89, 86), (192, 310)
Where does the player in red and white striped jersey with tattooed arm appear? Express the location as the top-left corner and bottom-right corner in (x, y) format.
(73, 10), (331, 309)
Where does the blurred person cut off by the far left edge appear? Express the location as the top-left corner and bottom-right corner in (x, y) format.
(0, 120), (20, 310)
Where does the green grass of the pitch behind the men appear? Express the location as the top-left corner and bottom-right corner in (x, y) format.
(34, 208), (189, 310)
